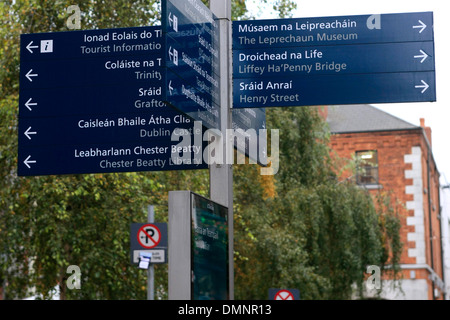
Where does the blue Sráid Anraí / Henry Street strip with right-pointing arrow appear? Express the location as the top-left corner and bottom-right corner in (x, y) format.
(233, 72), (436, 108)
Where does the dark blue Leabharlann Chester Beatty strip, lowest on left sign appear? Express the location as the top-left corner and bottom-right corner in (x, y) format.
(18, 139), (208, 176)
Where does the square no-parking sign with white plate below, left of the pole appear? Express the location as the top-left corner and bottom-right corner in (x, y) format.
(130, 223), (167, 264)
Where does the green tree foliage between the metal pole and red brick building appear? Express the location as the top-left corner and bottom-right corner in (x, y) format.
(235, 107), (401, 299)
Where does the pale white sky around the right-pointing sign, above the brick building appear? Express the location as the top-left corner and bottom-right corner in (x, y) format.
(250, 0), (450, 183)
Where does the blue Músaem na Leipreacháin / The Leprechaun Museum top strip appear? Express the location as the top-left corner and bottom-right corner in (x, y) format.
(233, 12), (434, 50)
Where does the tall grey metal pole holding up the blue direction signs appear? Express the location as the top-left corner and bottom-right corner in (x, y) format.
(209, 0), (234, 300)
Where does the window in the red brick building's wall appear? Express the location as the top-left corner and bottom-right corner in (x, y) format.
(356, 150), (378, 185)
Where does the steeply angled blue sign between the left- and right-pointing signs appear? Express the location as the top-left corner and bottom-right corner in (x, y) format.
(162, 0), (220, 129)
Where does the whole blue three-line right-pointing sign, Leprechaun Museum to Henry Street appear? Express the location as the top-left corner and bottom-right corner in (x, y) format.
(233, 12), (436, 108)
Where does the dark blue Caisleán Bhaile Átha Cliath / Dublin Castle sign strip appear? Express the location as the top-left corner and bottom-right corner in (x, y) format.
(19, 109), (194, 147)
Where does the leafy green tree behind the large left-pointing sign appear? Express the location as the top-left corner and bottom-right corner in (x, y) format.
(0, 0), (186, 299)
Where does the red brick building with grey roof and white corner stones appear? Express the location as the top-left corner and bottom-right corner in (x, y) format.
(325, 105), (445, 300)
